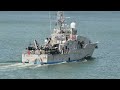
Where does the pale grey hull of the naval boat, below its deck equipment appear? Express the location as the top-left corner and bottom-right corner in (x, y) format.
(22, 43), (97, 64)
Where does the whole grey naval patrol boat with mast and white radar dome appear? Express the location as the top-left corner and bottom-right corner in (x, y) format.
(22, 11), (98, 64)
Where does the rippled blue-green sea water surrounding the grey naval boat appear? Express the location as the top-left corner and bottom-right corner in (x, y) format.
(0, 11), (120, 79)
